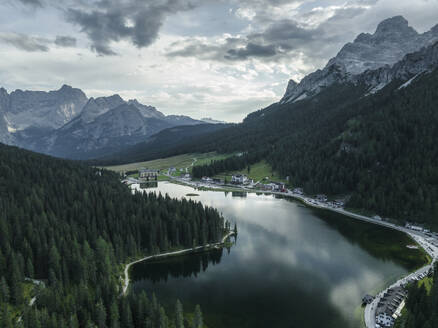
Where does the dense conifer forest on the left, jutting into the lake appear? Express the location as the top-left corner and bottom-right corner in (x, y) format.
(0, 145), (224, 328)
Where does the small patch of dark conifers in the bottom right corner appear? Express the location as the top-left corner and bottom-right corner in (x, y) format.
(395, 265), (438, 328)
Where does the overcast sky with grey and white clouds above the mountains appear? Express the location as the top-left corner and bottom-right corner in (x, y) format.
(0, 0), (438, 122)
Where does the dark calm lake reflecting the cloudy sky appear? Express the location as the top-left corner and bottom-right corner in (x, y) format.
(131, 182), (424, 328)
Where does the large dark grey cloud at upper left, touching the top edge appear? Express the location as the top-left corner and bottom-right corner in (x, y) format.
(66, 0), (199, 55)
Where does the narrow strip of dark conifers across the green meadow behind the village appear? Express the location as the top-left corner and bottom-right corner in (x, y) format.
(192, 152), (264, 179)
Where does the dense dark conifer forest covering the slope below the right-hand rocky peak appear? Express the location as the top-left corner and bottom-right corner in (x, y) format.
(145, 71), (438, 227)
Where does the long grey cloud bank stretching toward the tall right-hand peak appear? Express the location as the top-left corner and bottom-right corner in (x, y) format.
(167, 0), (375, 62)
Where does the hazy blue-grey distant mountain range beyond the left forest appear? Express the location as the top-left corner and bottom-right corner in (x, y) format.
(0, 85), (226, 159)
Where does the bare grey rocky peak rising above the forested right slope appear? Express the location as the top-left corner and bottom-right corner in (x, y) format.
(280, 16), (438, 103)
